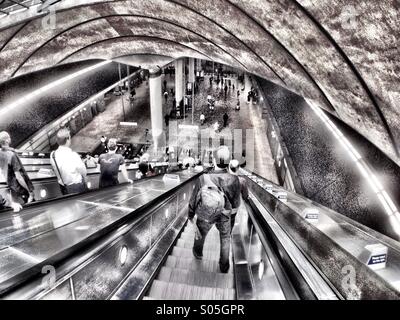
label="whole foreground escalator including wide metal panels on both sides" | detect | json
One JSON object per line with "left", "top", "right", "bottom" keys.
{"left": 0, "top": 171, "right": 400, "bottom": 300}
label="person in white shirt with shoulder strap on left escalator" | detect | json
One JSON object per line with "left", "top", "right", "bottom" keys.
{"left": 50, "top": 129, "right": 87, "bottom": 194}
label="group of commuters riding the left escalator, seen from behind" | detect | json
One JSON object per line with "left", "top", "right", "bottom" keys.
{"left": 0, "top": 128, "right": 159, "bottom": 212}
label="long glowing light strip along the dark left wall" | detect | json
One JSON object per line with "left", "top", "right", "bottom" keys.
{"left": 0, "top": 60, "right": 111, "bottom": 116}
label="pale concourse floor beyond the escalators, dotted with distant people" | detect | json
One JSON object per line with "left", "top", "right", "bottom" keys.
{"left": 71, "top": 70, "right": 278, "bottom": 183}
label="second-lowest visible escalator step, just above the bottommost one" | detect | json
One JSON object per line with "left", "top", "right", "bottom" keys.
{"left": 157, "top": 267, "right": 234, "bottom": 289}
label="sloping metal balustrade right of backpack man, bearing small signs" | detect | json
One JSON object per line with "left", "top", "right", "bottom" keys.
{"left": 242, "top": 170, "right": 400, "bottom": 299}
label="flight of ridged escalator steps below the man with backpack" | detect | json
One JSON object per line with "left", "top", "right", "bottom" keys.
{"left": 144, "top": 225, "right": 236, "bottom": 300}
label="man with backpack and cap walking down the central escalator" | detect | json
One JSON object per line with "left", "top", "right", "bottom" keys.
{"left": 189, "top": 146, "right": 240, "bottom": 273}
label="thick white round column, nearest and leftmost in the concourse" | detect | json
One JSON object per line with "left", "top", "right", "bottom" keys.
{"left": 149, "top": 67, "right": 165, "bottom": 150}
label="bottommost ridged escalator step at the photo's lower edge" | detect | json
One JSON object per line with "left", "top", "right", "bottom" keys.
{"left": 148, "top": 280, "right": 235, "bottom": 300}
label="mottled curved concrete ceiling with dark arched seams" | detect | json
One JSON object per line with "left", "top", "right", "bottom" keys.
{"left": 0, "top": 0, "right": 400, "bottom": 165}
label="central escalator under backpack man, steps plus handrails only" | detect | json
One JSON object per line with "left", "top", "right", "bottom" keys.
{"left": 109, "top": 172, "right": 337, "bottom": 300}
